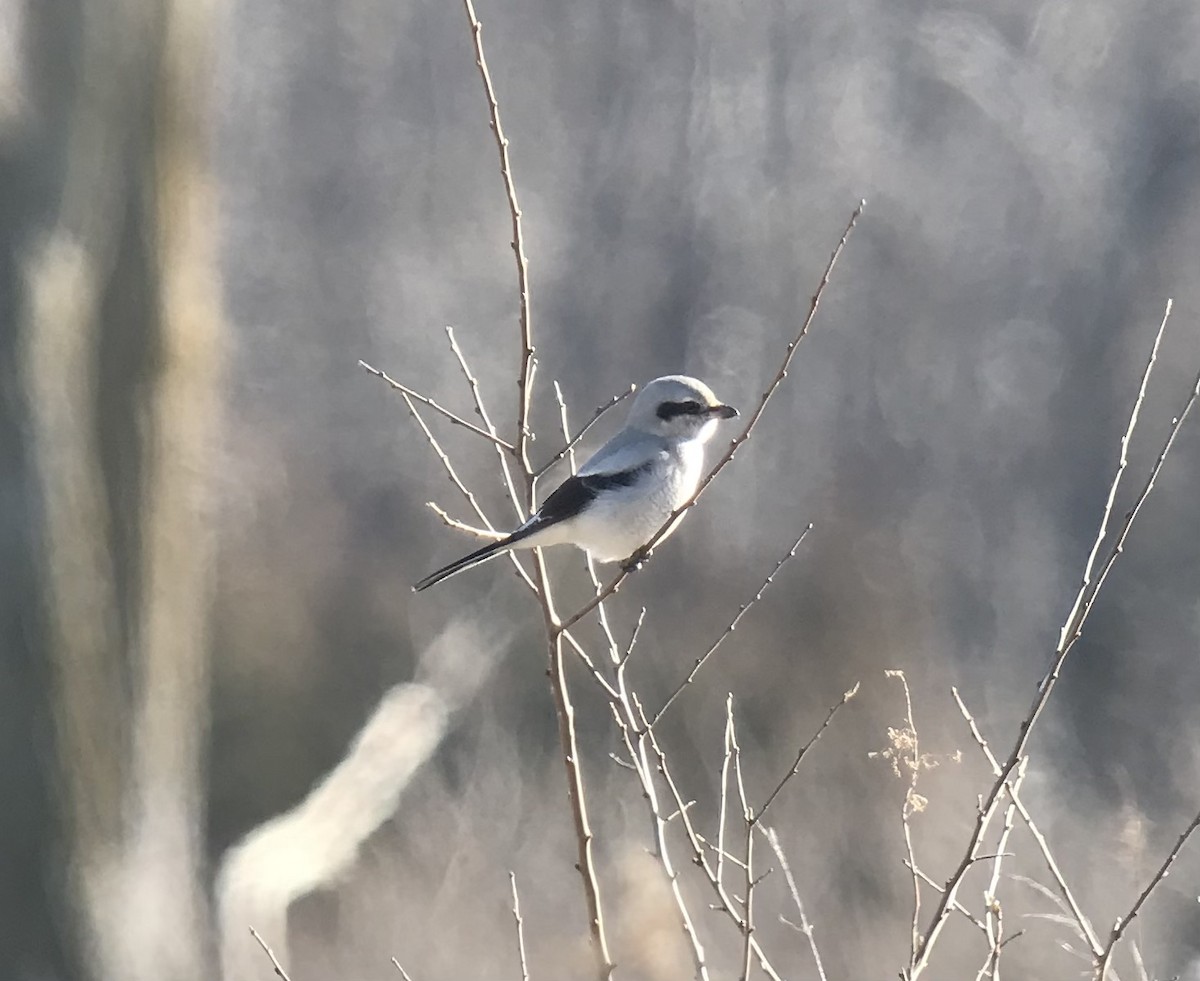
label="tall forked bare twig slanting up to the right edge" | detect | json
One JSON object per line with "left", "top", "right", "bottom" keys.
{"left": 908, "top": 302, "right": 1200, "bottom": 981}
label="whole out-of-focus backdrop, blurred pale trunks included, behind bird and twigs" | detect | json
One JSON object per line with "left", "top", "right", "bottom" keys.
{"left": 0, "top": 0, "right": 1200, "bottom": 981}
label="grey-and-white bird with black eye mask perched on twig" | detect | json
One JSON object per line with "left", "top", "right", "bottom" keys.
{"left": 413, "top": 374, "right": 738, "bottom": 592}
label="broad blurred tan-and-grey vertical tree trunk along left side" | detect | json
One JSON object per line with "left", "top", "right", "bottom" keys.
{"left": 5, "top": 0, "right": 222, "bottom": 981}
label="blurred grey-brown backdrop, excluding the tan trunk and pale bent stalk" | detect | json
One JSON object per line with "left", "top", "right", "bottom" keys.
{"left": 0, "top": 0, "right": 1200, "bottom": 979}
